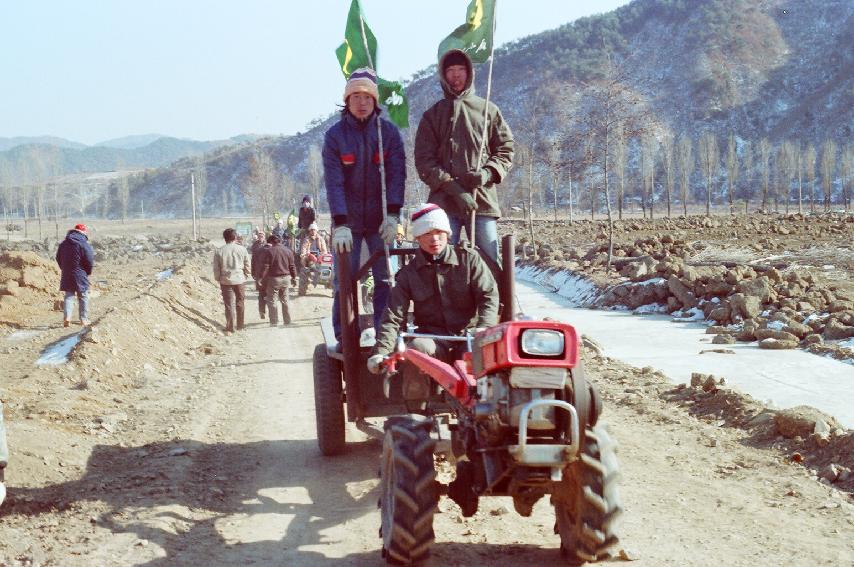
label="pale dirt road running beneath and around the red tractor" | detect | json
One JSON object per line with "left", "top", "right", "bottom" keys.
{"left": 0, "top": 271, "right": 854, "bottom": 566}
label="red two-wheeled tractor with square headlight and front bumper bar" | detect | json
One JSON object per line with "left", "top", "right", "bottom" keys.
{"left": 315, "top": 237, "right": 622, "bottom": 565}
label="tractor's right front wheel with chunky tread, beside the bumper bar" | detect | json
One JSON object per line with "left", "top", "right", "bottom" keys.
{"left": 552, "top": 424, "right": 623, "bottom": 565}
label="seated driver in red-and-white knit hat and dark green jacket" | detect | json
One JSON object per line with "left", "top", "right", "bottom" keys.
{"left": 368, "top": 204, "right": 498, "bottom": 386}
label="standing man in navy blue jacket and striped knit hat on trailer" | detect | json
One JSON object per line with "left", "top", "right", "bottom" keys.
{"left": 323, "top": 68, "right": 406, "bottom": 338}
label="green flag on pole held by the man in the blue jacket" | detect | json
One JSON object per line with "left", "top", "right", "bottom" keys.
{"left": 335, "top": 0, "right": 409, "bottom": 128}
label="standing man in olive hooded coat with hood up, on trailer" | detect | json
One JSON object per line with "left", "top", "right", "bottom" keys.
{"left": 415, "top": 49, "right": 513, "bottom": 263}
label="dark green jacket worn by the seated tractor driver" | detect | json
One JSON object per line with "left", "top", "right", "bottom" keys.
{"left": 374, "top": 246, "right": 498, "bottom": 354}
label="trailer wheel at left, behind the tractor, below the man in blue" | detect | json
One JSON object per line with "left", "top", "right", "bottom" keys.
{"left": 314, "top": 344, "right": 344, "bottom": 456}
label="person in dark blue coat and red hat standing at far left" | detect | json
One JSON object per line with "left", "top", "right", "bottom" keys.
{"left": 56, "top": 224, "right": 95, "bottom": 327}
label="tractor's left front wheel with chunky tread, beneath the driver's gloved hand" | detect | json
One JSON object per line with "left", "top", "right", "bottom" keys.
{"left": 379, "top": 417, "right": 439, "bottom": 565}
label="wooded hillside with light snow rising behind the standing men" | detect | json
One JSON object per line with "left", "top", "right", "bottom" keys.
{"left": 112, "top": 0, "right": 854, "bottom": 220}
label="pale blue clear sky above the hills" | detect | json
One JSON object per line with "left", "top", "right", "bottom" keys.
{"left": 0, "top": 0, "right": 627, "bottom": 144}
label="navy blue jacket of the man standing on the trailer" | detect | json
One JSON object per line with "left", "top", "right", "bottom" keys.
{"left": 323, "top": 112, "right": 406, "bottom": 233}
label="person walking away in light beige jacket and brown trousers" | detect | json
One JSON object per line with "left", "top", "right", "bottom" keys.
{"left": 214, "top": 228, "right": 252, "bottom": 334}
